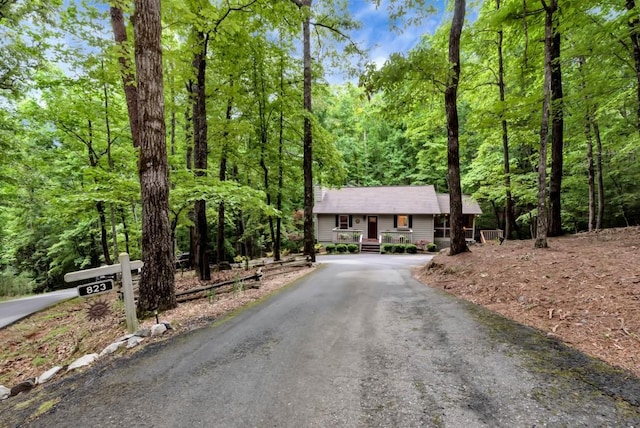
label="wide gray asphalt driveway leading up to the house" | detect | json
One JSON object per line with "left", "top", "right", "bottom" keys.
{"left": 8, "top": 255, "right": 640, "bottom": 428}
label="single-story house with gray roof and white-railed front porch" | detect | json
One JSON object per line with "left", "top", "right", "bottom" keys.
{"left": 313, "top": 186, "right": 482, "bottom": 250}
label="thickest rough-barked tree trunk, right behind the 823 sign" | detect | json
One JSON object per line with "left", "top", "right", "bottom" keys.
{"left": 134, "top": 0, "right": 177, "bottom": 313}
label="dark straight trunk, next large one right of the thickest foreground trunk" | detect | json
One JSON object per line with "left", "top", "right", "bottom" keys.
{"left": 191, "top": 31, "right": 211, "bottom": 281}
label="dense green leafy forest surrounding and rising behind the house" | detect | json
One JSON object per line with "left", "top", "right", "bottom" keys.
{"left": 0, "top": 0, "right": 640, "bottom": 294}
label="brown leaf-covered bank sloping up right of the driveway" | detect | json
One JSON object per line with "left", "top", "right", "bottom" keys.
{"left": 418, "top": 227, "right": 640, "bottom": 376}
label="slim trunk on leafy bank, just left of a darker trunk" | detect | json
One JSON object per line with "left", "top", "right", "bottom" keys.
{"left": 535, "top": 0, "right": 553, "bottom": 248}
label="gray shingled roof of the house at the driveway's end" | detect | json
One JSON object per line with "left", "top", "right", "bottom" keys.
{"left": 313, "top": 185, "right": 482, "bottom": 214}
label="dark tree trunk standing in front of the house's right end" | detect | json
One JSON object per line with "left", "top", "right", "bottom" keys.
{"left": 444, "top": 0, "right": 469, "bottom": 256}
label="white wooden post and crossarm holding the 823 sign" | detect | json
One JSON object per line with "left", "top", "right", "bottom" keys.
{"left": 64, "top": 253, "right": 143, "bottom": 333}
